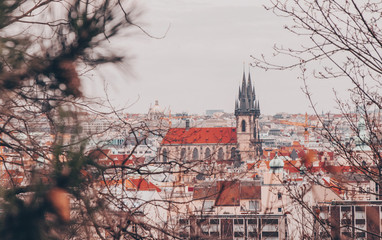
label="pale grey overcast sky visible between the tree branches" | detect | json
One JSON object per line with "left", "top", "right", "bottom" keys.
{"left": 85, "top": 0, "right": 354, "bottom": 114}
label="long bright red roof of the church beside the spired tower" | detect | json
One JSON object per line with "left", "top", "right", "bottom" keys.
{"left": 162, "top": 127, "right": 237, "bottom": 144}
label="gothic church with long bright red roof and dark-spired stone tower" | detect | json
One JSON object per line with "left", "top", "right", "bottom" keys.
{"left": 158, "top": 70, "right": 262, "bottom": 164}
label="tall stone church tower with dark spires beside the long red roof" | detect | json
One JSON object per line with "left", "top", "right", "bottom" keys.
{"left": 235, "top": 68, "right": 262, "bottom": 161}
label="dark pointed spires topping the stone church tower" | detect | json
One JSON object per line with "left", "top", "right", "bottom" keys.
{"left": 235, "top": 67, "right": 260, "bottom": 115}
